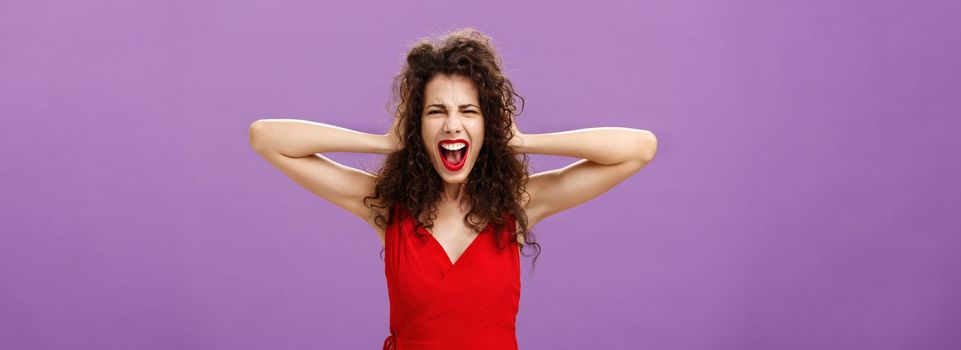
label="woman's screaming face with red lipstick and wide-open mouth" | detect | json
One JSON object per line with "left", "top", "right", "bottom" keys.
{"left": 421, "top": 74, "right": 484, "bottom": 184}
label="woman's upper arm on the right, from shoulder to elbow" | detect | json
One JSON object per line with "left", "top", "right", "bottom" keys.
{"left": 526, "top": 134, "right": 656, "bottom": 226}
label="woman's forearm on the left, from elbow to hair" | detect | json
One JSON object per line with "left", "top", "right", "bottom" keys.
{"left": 250, "top": 119, "right": 396, "bottom": 157}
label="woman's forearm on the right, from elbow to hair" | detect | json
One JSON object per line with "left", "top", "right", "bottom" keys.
{"left": 515, "top": 127, "right": 657, "bottom": 164}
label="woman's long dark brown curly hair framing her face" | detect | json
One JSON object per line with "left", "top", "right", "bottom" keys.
{"left": 364, "top": 28, "right": 541, "bottom": 268}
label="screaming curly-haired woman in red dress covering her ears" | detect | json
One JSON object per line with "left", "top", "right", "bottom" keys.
{"left": 250, "top": 28, "right": 657, "bottom": 349}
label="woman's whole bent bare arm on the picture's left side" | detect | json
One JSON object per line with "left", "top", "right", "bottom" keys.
{"left": 250, "top": 119, "right": 402, "bottom": 239}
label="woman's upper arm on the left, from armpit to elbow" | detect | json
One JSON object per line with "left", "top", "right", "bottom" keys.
{"left": 251, "top": 136, "right": 383, "bottom": 239}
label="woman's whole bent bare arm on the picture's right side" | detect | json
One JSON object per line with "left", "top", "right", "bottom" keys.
{"left": 509, "top": 123, "right": 657, "bottom": 226}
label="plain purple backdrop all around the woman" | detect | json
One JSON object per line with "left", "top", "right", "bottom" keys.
{"left": 0, "top": 0, "right": 961, "bottom": 349}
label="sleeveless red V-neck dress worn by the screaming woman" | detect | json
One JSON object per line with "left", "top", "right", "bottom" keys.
{"left": 384, "top": 205, "right": 521, "bottom": 350}
